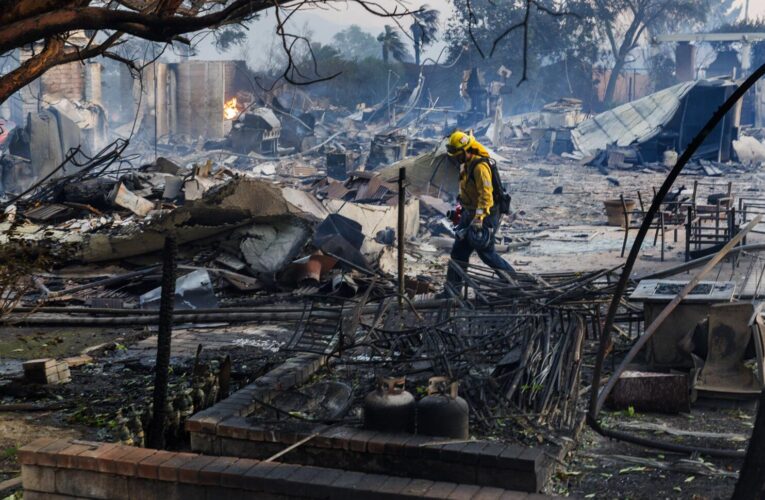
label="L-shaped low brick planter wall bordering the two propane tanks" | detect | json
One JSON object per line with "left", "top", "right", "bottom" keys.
{"left": 186, "top": 354, "right": 552, "bottom": 493}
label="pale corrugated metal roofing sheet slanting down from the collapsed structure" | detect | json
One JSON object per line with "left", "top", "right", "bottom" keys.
{"left": 571, "top": 82, "right": 698, "bottom": 154}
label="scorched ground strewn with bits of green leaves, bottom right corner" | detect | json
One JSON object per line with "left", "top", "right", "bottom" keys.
{"left": 551, "top": 403, "right": 755, "bottom": 499}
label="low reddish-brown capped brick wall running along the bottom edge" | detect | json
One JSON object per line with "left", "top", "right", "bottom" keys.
{"left": 19, "top": 439, "right": 547, "bottom": 500}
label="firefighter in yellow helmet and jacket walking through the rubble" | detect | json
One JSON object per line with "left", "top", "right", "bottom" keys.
{"left": 446, "top": 131, "right": 514, "bottom": 290}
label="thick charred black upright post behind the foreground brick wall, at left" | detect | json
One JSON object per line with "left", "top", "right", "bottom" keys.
{"left": 147, "top": 236, "right": 178, "bottom": 450}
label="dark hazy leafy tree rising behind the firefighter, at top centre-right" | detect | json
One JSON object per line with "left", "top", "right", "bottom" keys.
{"left": 444, "top": 0, "right": 601, "bottom": 113}
